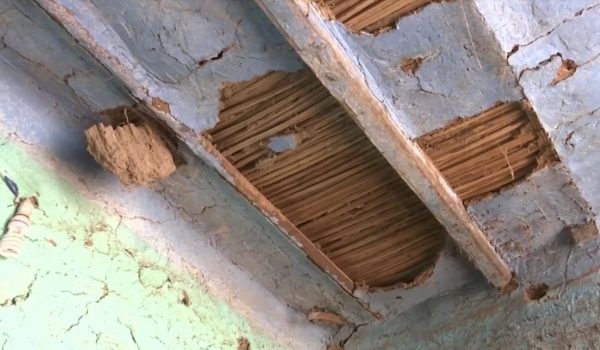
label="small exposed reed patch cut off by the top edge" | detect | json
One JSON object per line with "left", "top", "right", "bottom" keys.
{"left": 317, "top": 0, "right": 432, "bottom": 33}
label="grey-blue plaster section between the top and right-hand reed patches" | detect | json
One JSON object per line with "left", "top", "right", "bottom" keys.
{"left": 347, "top": 1, "right": 522, "bottom": 137}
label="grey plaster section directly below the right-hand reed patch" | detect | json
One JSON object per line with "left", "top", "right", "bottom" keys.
{"left": 468, "top": 165, "right": 600, "bottom": 286}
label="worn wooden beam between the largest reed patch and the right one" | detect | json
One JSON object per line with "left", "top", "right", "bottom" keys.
{"left": 255, "top": 0, "right": 512, "bottom": 287}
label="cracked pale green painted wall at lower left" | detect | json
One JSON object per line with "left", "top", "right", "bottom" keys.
{"left": 0, "top": 139, "right": 283, "bottom": 350}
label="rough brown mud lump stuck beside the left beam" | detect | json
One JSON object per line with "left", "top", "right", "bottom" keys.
{"left": 85, "top": 122, "right": 176, "bottom": 185}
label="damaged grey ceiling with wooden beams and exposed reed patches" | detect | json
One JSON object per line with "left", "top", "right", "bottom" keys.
{"left": 4, "top": 0, "right": 600, "bottom": 342}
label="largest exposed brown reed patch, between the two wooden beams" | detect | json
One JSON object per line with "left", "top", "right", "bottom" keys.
{"left": 207, "top": 71, "right": 445, "bottom": 287}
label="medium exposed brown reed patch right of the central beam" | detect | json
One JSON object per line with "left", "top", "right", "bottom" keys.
{"left": 418, "top": 102, "right": 555, "bottom": 200}
